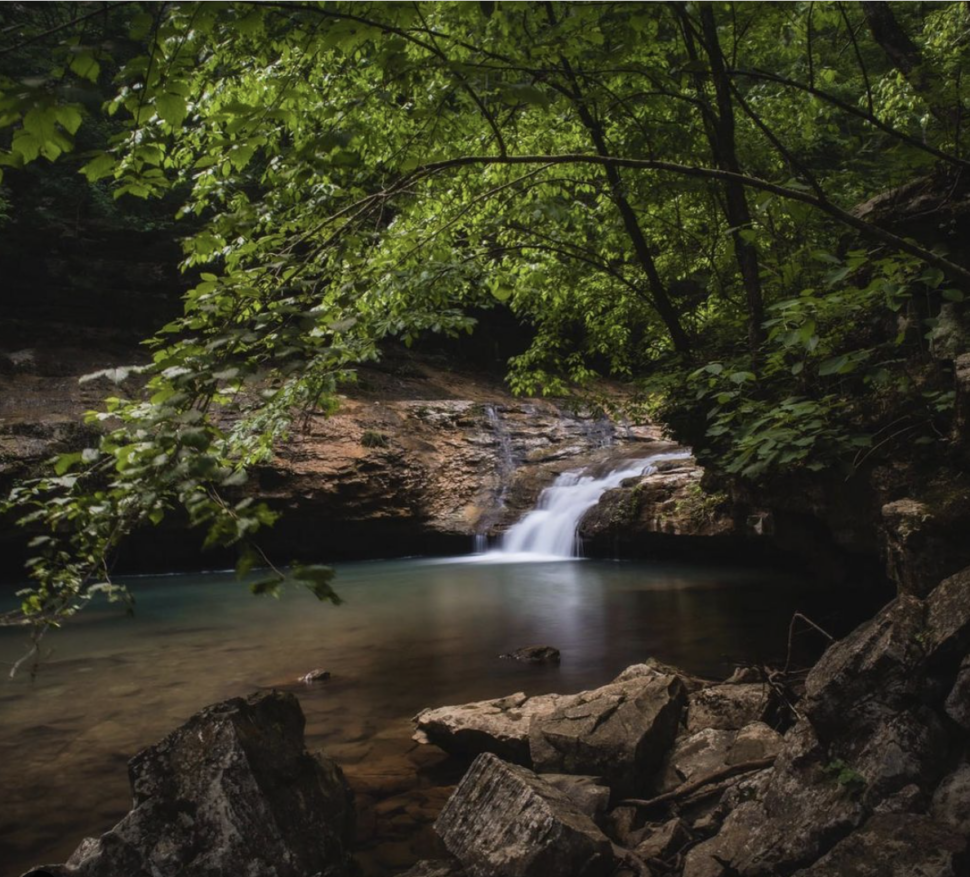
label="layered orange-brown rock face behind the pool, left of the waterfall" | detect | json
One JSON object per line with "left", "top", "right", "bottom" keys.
{"left": 0, "top": 346, "right": 670, "bottom": 573}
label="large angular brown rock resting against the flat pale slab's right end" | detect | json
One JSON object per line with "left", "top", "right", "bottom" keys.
{"left": 529, "top": 676, "right": 686, "bottom": 795}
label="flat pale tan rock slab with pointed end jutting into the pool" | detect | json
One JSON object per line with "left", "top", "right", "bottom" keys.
{"left": 414, "top": 692, "right": 563, "bottom": 766}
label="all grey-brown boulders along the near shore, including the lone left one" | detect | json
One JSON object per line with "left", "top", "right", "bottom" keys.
{"left": 28, "top": 569, "right": 970, "bottom": 877}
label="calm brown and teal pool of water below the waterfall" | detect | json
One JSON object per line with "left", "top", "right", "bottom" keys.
{"left": 0, "top": 559, "right": 874, "bottom": 875}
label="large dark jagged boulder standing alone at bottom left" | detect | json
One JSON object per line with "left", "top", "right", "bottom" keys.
{"left": 28, "top": 692, "right": 354, "bottom": 877}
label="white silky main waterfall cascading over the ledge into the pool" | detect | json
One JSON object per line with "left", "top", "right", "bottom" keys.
{"left": 501, "top": 451, "right": 690, "bottom": 557}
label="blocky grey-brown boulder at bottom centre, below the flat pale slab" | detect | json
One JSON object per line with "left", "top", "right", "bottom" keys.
{"left": 435, "top": 753, "right": 615, "bottom": 877}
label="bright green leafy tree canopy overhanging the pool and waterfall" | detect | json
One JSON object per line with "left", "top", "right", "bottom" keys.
{"left": 0, "top": 2, "right": 970, "bottom": 640}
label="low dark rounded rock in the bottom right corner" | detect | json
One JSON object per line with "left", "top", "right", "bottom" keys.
{"left": 795, "top": 813, "right": 970, "bottom": 877}
